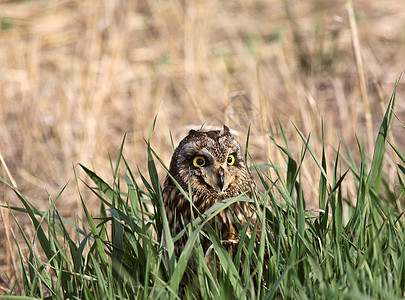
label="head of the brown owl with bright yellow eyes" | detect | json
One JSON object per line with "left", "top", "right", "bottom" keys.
{"left": 169, "top": 126, "right": 249, "bottom": 197}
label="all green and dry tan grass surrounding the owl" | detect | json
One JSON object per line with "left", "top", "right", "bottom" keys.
{"left": 0, "top": 0, "right": 405, "bottom": 298}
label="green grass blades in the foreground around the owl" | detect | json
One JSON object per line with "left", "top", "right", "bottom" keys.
{"left": 0, "top": 78, "right": 405, "bottom": 299}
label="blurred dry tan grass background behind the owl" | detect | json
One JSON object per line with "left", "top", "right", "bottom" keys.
{"left": 0, "top": 0, "right": 405, "bottom": 292}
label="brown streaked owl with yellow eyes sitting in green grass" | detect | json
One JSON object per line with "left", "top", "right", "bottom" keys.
{"left": 163, "top": 126, "right": 256, "bottom": 255}
